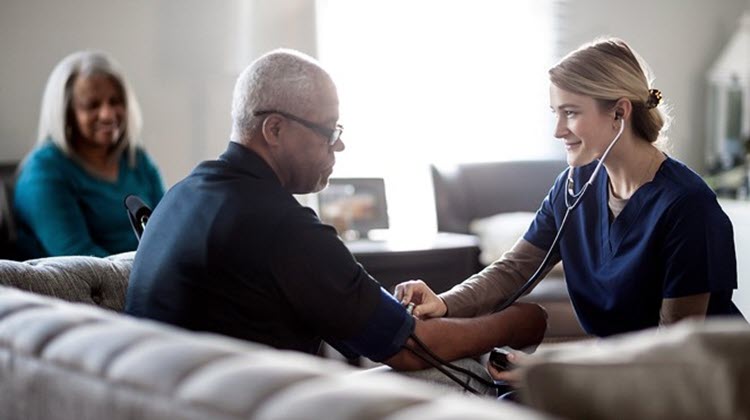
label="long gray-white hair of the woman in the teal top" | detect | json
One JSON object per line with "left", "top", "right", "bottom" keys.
{"left": 37, "top": 51, "right": 143, "bottom": 165}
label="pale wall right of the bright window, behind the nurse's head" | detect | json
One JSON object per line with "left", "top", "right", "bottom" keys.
{"left": 560, "top": 0, "right": 750, "bottom": 171}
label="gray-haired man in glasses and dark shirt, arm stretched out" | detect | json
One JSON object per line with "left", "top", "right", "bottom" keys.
{"left": 126, "top": 50, "right": 546, "bottom": 380}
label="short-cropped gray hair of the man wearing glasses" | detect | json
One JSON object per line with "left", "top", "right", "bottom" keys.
{"left": 231, "top": 49, "right": 331, "bottom": 141}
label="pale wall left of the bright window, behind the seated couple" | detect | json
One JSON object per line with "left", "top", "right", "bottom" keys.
{"left": 0, "top": 0, "right": 315, "bottom": 185}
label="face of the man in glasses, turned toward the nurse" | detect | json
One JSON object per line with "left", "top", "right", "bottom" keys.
{"left": 281, "top": 82, "right": 344, "bottom": 194}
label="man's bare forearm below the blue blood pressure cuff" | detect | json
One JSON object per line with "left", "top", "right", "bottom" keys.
{"left": 385, "top": 303, "right": 547, "bottom": 370}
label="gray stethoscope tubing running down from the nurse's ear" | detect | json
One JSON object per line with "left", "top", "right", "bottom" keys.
{"left": 493, "top": 115, "right": 625, "bottom": 312}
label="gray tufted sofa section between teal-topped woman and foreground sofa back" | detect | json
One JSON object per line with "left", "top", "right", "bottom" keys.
{"left": 0, "top": 252, "right": 135, "bottom": 312}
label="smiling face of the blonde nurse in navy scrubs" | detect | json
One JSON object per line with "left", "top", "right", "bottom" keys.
{"left": 549, "top": 84, "right": 619, "bottom": 166}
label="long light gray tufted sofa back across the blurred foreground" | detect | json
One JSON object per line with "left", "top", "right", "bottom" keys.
{"left": 0, "top": 287, "right": 546, "bottom": 420}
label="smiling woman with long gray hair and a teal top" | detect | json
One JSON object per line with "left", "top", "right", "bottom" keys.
{"left": 14, "top": 51, "right": 164, "bottom": 258}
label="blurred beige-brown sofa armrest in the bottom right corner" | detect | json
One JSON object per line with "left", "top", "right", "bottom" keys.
{"left": 521, "top": 318, "right": 750, "bottom": 419}
